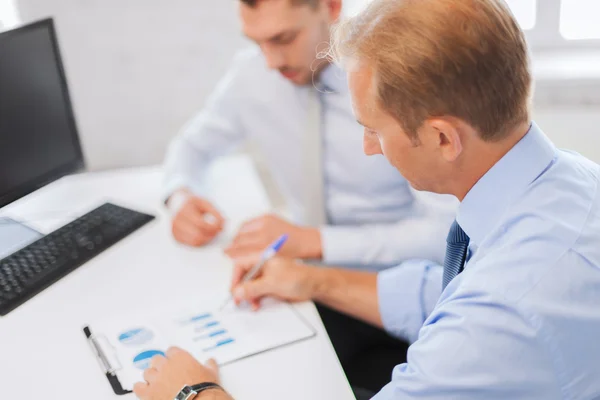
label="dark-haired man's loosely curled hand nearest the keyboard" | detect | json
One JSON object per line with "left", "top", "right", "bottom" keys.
{"left": 172, "top": 194, "right": 224, "bottom": 247}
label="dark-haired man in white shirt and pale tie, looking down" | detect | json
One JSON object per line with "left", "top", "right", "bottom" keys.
{"left": 159, "top": 0, "right": 456, "bottom": 390}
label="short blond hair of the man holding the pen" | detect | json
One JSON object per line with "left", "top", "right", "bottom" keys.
{"left": 330, "top": 0, "right": 532, "bottom": 141}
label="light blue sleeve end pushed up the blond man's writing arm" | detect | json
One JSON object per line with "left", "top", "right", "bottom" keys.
{"left": 377, "top": 260, "right": 442, "bottom": 343}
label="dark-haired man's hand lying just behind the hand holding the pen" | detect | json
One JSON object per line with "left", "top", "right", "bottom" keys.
{"left": 225, "top": 215, "right": 323, "bottom": 259}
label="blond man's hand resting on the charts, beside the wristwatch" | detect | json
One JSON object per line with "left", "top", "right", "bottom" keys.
{"left": 133, "top": 347, "right": 231, "bottom": 400}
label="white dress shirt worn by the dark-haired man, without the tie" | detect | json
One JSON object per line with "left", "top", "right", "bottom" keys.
{"left": 165, "top": 49, "right": 457, "bottom": 268}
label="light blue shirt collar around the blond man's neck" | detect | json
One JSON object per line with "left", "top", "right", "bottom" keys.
{"left": 456, "top": 122, "right": 556, "bottom": 246}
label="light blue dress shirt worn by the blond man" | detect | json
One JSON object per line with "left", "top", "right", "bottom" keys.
{"left": 375, "top": 124, "right": 600, "bottom": 400}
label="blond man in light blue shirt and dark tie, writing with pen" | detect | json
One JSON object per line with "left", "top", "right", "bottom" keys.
{"left": 136, "top": 0, "right": 600, "bottom": 400}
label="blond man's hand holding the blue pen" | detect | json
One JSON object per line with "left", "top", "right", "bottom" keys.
{"left": 231, "top": 257, "right": 319, "bottom": 310}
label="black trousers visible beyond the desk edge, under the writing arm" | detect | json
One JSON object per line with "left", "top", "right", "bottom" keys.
{"left": 317, "top": 305, "right": 408, "bottom": 399}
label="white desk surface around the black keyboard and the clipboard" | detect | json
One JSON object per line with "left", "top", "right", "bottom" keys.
{"left": 0, "top": 157, "right": 354, "bottom": 400}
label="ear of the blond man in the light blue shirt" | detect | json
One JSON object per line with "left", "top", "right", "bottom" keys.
{"left": 421, "top": 118, "right": 463, "bottom": 162}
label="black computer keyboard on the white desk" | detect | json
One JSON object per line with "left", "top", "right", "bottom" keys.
{"left": 0, "top": 203, "right": 154, "bottom": 315}
